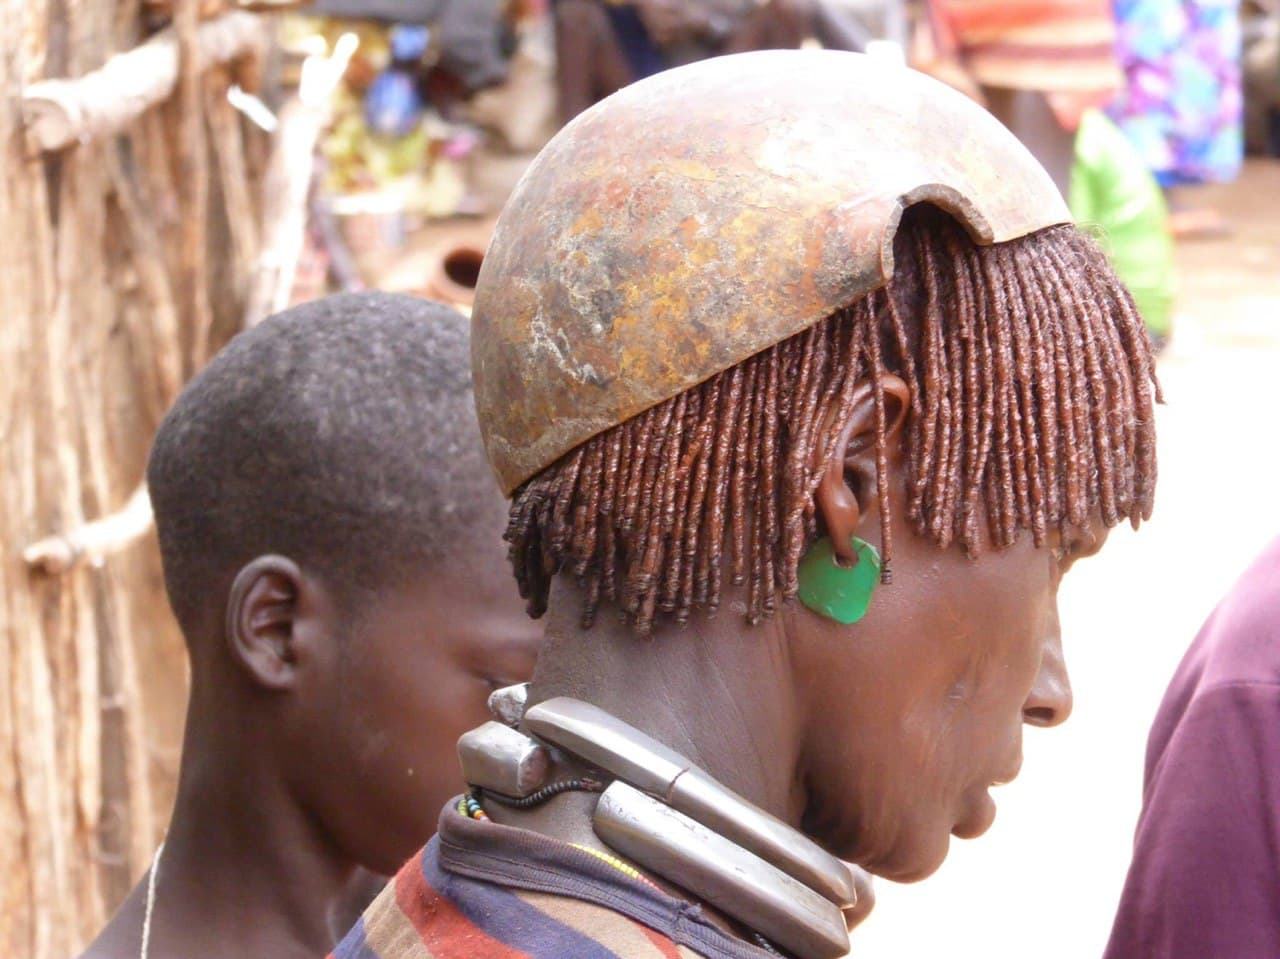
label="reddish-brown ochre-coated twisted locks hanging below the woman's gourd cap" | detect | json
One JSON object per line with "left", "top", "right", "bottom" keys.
{"left": 507, "top": 207, "right": 1160, "bottom": 634}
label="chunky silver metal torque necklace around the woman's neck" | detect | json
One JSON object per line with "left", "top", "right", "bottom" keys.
{"left": 458, "top": 686, "right": 858, "bottom": 959}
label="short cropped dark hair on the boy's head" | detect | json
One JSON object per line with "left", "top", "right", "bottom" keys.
{"left": 147, "top": 293, "right": 503, "bottom": 630}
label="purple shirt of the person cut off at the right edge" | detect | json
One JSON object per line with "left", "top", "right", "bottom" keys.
{"left": 1106, "top": 540, "right": 1280, "bottom": 959}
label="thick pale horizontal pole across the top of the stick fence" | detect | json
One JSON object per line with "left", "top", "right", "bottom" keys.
{"left": 22, "top": 12, "right": 266, "bottom": 150}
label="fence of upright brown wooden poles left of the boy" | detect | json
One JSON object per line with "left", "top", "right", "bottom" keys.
{"left": 0, "top": 0, "right": 265, "bottom": 959}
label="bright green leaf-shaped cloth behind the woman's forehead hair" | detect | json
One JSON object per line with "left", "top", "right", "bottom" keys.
{"left": 1070, "top": 110, "right": 1174, "bottom": 335}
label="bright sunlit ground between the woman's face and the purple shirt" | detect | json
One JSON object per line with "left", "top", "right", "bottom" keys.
{"left": 852, "top": 161, "right": 1280, "bottom": 959}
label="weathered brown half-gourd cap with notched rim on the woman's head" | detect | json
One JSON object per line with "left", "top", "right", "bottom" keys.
{"left": 471, "top": 51, "right": 1070, "bottom": 496}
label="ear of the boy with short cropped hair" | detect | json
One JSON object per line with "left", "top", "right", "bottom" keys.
{"left": 227, "top": 556, "right": 302, "bottom": 690}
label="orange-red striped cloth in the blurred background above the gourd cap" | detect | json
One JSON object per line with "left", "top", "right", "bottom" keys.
{"left": 928, "top": 0, "right": 1123, "bottom": 93}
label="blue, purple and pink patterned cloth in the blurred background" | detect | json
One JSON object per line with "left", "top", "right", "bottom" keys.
{"left": 1108, "top": 0, "right": 1244, "bottom": 187}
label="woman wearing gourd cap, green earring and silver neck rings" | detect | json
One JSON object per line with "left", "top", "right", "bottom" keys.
{"left": 338, "top": 51, "right": 1158, "bottom": 959}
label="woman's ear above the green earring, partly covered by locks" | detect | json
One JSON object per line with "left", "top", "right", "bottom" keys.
{"left": 814, "top": 373, "right": 911, "bottom": 563}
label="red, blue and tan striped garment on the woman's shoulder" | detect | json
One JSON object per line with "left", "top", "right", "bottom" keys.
{"left": 330, "top": 804, "right": 771, "bottom": 959}
